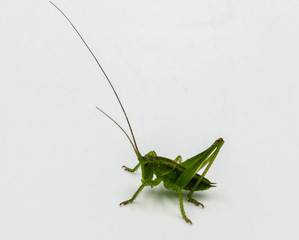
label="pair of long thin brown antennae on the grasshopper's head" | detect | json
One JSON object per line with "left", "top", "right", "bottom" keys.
{"left": 50, "top": 1, "right": 140, "bottom": 155}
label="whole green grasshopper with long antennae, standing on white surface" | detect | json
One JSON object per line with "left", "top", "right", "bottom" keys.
{"left": 50, "top": 2, "right": 224, "bottom": 224}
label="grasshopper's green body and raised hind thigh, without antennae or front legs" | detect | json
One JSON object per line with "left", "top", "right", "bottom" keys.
{"left": 138, "top": 138, "right": 224, "bottom": 191}
